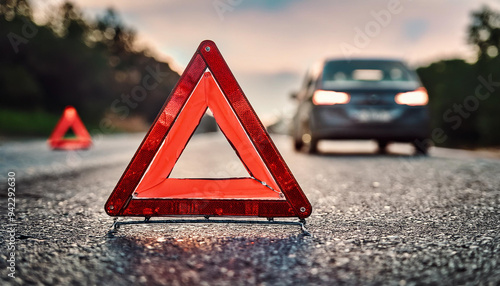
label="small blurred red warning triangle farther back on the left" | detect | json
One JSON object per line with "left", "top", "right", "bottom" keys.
{"left": 49, "top": 106, "right": 92, "bottom": 150}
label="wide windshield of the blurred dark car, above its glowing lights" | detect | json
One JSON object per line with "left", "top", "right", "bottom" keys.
{"left": 322, "top": 60, "right": 419, "bottom": 89}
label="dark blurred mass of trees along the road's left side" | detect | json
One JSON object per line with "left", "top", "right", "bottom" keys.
{"left": 0, "top": 0, "right": 179, "bottom": 133}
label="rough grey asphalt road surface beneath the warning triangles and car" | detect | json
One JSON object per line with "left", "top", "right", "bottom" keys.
{"left": 0, "top": 134, "right": 500, "bottom": 285}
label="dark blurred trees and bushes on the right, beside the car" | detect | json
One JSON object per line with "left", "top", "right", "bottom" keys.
{"left": 417, "top": 7, "right": 500, "bottom": 147}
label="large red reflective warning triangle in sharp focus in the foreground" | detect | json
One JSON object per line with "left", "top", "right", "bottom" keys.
{"left": 105, "top": 41, "right": 312, "bottom": 218}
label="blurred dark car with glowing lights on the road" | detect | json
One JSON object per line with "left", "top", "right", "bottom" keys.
{"left": 291, "top": 59, "right": 430, "bottom": 154}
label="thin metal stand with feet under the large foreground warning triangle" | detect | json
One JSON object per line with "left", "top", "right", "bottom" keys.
{"left": 108, "top": 217, "right": 311, "bottom": 236}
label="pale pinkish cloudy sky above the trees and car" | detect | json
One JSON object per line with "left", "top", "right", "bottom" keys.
{"left": 34, "top": 0, "right": 500, "bottom": 116}
